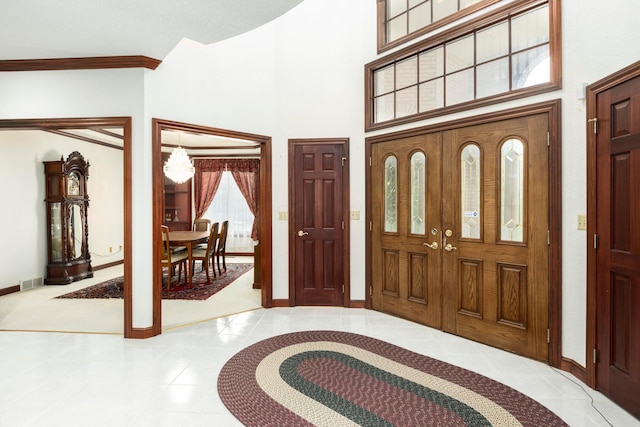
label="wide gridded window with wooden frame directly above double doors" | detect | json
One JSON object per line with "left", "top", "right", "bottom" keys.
{"left": 365, "top": 0, "right": 561, "bottom": 130}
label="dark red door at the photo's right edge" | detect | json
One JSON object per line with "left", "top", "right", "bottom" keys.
{"left": 596, "top": 77, "right": 640, "bottom": 418}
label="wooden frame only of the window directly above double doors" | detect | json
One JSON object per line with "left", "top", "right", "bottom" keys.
{"left": 365, "top": 0, "right": 562, "bottom": 132}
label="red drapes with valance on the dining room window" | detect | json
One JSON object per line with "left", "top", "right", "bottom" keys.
{"left": 193, "top": 159, "right": 260, "bottom": 240}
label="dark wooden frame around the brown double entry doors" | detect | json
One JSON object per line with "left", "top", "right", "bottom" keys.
{"left": 365, "top": 99, "right": 564, "bottom": 368}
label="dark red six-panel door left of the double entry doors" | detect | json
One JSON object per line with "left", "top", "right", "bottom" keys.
{"left": 289, "top": 141, "right": 346, "bottom": 306}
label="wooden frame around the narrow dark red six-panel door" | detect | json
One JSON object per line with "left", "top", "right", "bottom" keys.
{"left": 288, "top": 138, "right": 351, "bottom": 307}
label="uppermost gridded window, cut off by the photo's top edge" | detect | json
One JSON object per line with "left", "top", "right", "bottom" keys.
{"left": 378, "top": 0, "right": 500, "bottom": 52}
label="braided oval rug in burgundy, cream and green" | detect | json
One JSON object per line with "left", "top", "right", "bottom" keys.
{"left": 218, "top": 331, "right": 567, "bottom": 427}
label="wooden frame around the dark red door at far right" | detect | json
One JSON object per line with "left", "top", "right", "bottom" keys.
{"left": 585, "top": 61, "right": 640, "bottom": 388}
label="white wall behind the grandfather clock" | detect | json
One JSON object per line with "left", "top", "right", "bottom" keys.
{"left": 0, "top": 131, "right": 124, "bottom": 287}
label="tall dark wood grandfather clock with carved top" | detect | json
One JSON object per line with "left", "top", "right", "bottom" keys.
{"left": 43, "top": 151, "right": 93, "bottom": 285}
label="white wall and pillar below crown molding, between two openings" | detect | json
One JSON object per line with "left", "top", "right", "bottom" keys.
{"left": 0, "top": 69, "right": 152, "bottom": 328}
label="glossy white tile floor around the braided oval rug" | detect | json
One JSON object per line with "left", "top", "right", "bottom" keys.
{"left": 0, "top": 307, "right": 640, "bottom": 427}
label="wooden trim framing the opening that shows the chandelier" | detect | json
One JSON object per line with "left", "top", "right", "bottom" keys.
{"left": 151, "top": 118, "right": 273, "bottom": 335}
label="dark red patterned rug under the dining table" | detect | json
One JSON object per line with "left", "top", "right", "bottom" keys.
{"left": 57, "top": 263, "right": 253, "bottom": 301}
